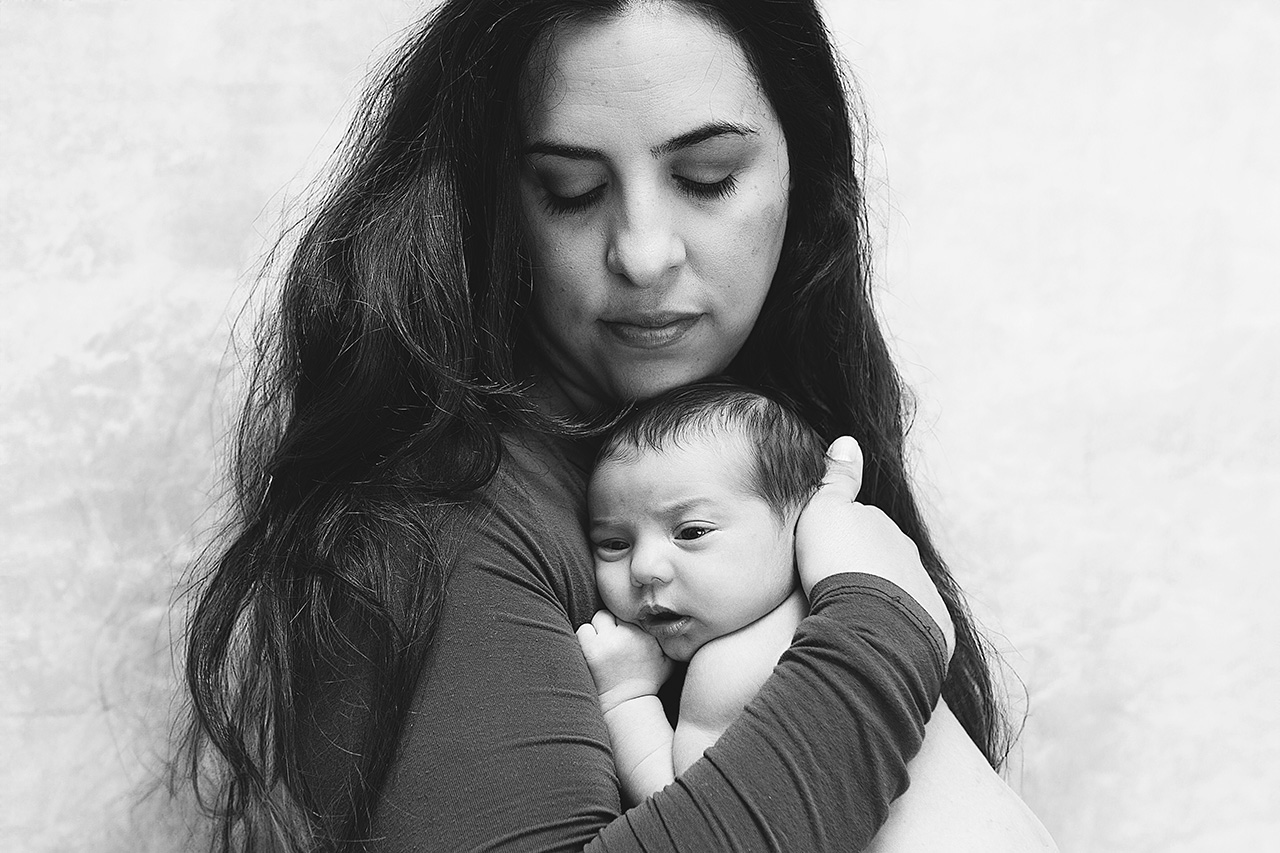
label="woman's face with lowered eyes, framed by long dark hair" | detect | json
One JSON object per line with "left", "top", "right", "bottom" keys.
{"left": 520, "top": 3, "right": 790, "bottom": 411}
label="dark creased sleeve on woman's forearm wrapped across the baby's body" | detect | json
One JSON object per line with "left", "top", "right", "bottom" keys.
{"left": 599, "top": 574, "right": 945, "bottom": 853}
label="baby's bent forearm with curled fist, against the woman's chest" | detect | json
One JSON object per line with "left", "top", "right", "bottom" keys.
{"left": 577, "top": 610, "right": 676, "bottom": 807}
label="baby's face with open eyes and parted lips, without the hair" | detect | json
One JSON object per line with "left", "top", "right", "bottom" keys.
{"left": 588, "top": 435, "right": 795, "bottom": 661}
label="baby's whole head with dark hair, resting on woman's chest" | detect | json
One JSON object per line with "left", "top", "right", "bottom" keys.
{"left": 588, "top": 382, "right": 826, "bottom": 661}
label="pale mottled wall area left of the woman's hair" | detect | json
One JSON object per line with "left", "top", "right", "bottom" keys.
{"left": 0, "top": 0, "right": 413, "bottom": 852}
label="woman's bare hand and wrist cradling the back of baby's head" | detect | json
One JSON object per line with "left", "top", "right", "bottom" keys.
{"left": 796, "top": 435, "right": 955, "bottom": 654}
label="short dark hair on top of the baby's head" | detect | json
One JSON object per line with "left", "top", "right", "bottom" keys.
{"left": 595, "top": 379, "right": 827, "bottom": 517}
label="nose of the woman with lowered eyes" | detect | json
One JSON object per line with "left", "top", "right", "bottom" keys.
{"left": 604, "top": 193, "right": 685, "bottom": 287}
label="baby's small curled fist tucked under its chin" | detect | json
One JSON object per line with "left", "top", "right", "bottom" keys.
{"left": 577, "top": 610, "right": 671, "bottom": 712}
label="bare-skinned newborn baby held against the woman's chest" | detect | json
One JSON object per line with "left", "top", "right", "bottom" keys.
{"left": 577, "top": 383, "right": 1056, "bottom": 850}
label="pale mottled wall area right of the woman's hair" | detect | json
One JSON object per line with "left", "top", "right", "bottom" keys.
{"left": 829, "top": 1, "right": 1280, "bottom": 852}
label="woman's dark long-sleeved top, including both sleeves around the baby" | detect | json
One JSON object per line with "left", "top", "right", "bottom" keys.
{"left": 296, "top": 432, "right": 942, "bottom": 853}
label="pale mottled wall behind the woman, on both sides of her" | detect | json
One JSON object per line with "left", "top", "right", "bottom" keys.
{"left": 0, "top": 0, "right": 1280, "bottom": 853}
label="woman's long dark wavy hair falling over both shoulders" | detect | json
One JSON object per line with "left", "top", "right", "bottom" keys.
{"left": 183, "top": 0, "right": 1005, "bottom": 850}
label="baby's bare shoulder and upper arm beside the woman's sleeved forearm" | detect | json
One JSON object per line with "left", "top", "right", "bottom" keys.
{"left": 672, "top": 589, "right": 809, "bottom": 774}
